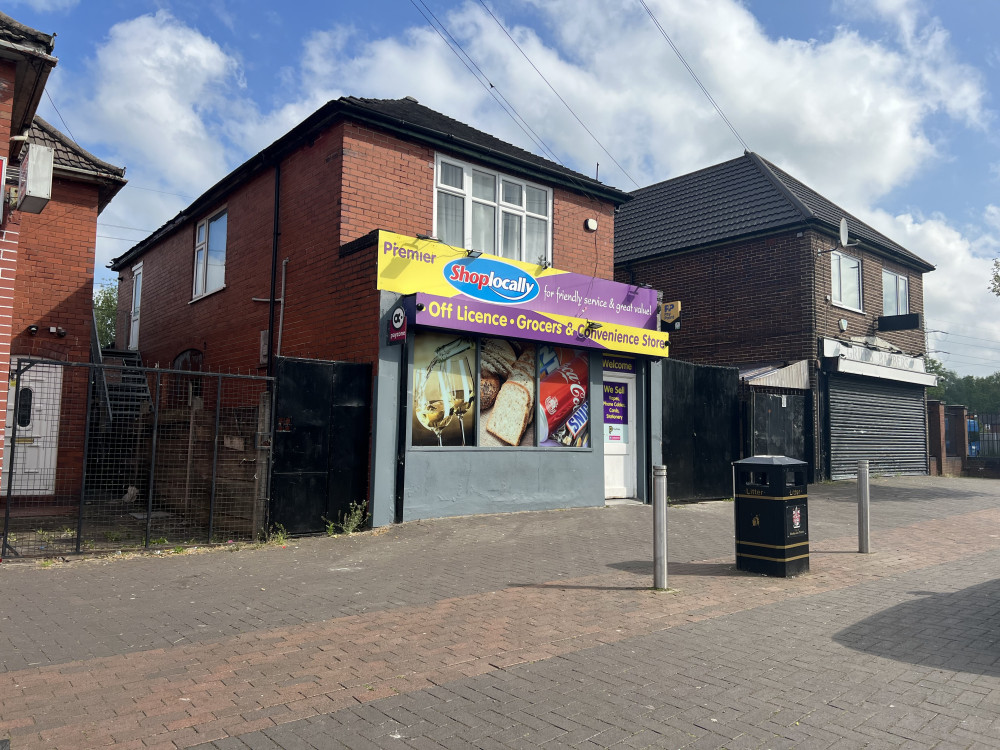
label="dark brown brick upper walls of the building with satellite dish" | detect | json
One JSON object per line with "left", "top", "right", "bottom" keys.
{"left": 616, "top": 231, "right": 924, "bottom": 366}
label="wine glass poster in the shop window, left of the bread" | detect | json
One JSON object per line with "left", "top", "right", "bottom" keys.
{"left": 412, "top": 331, "right": 476, "bottom": 447}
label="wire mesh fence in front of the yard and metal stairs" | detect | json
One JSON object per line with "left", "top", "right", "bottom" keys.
{"left": 0, "top": 360, "right": 272, "bottom": 556}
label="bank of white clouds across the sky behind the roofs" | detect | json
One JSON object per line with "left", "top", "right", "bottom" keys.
{"left": 53, "top": 0, "right": 1000, "bottom": 374}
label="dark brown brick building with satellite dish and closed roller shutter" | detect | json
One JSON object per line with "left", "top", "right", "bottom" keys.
{"left": 615, "top": 152, "right": 936, "bottom": 479}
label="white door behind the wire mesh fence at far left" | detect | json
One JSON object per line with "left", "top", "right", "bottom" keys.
{"left": 0, "top": 364, "right": 62, "bottom": 495}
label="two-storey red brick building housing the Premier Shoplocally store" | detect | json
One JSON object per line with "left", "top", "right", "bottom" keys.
{"left": 111, "top": 97, "right": 666, "bottom": 530}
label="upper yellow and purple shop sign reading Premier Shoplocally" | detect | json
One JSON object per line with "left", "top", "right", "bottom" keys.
{"left": 377, "top": 232, "right": 666, "bottom": 332}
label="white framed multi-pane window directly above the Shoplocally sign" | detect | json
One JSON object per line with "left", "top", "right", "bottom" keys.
{"left": 434, "top": 154, "right": 552, "bottom": 264}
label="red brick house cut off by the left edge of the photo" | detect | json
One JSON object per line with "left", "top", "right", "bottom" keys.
{"left": 0, "top": 13, "right": 125, "bottom": 505}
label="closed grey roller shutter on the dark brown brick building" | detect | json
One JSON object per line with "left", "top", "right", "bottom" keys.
{"left": 827, "top": 374, "right": 927, "bottom": 479}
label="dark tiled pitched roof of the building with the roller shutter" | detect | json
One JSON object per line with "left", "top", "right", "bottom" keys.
{"left": 615, "top": 151, "right": 934, "bottom": 271}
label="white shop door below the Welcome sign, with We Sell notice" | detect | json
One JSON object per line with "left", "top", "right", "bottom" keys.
{"left": 604, "top": 371, "right": 636, "bottom": 498}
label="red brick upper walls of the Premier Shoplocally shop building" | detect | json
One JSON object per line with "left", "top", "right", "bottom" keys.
{"left": 118, "top": 122, "right": 614, "bottom": 372}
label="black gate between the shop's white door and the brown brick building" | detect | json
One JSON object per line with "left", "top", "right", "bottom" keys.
{"left": 663, "top": 359, "right": 740, "bottom": 500}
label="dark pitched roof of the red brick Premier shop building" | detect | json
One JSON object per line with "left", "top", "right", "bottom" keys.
{"left": 109, "top": 96, "right": 631, "bottom": 271}
